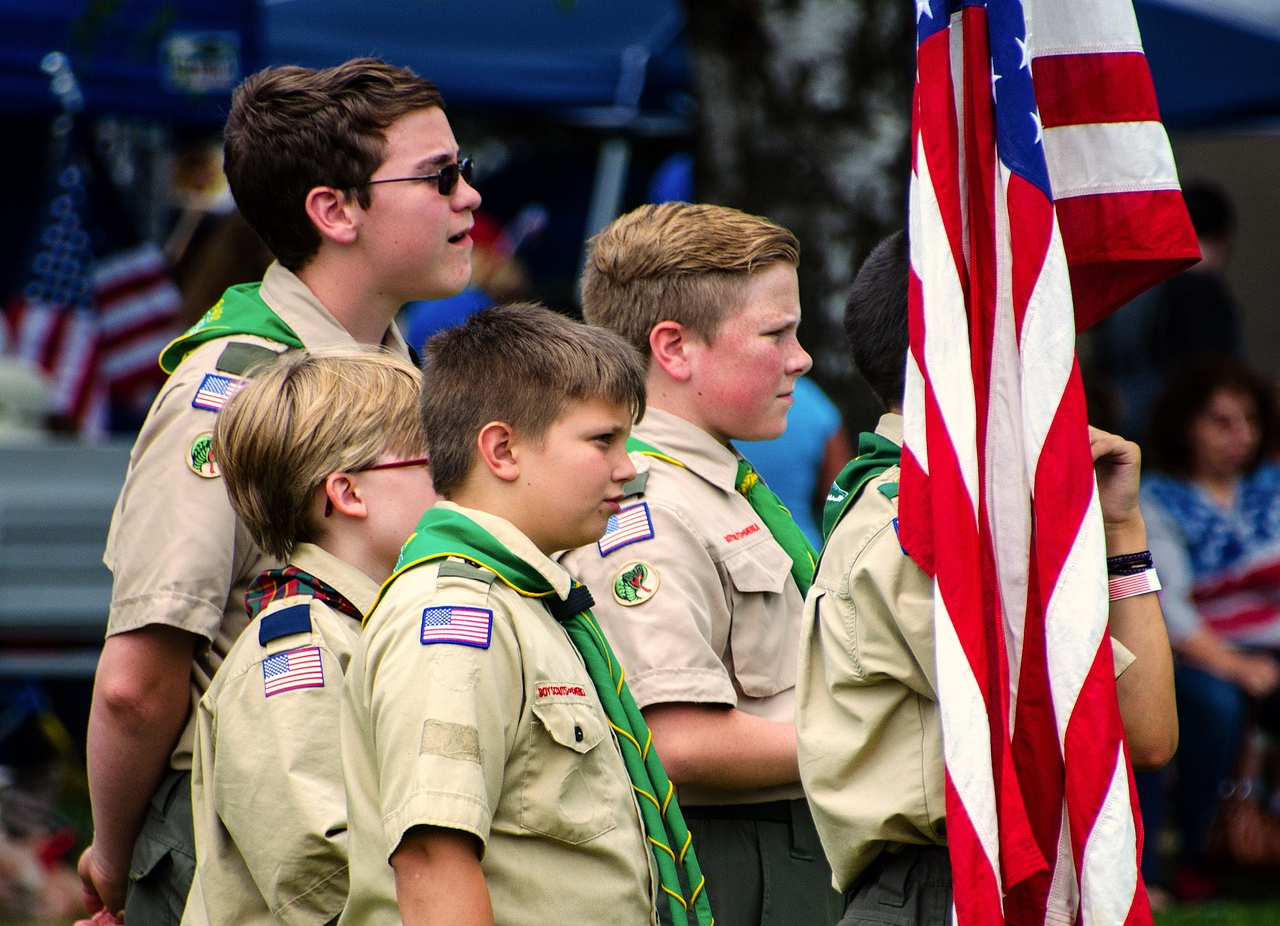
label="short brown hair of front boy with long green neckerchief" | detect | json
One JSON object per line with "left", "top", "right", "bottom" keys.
{"left": 421, "top": 302, "right": 645, "bottom": 498}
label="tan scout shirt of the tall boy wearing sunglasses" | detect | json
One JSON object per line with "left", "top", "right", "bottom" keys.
{"left": 102, "top": 264, "right": 408, "bottom": 768}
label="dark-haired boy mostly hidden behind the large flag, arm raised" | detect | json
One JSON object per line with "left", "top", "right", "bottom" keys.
{"left": 796, "top": 232, "right": 1178, "bottom": 926}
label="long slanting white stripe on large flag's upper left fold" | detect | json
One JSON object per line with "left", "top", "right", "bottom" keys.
{"left": 910, "top": 145, "right": 978, "bottom": 514}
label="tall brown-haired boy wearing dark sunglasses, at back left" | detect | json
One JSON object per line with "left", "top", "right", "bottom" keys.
{"left": 81, "top": 59, "right": 480, "bottom": 926}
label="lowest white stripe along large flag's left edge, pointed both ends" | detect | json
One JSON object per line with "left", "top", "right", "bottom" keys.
{"left": 933, "top": 583, "right": 1004, "bottom": 894}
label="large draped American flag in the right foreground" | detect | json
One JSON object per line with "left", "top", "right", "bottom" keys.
{"left": 900, "top": 0, "right": 1198, "bottom": 926}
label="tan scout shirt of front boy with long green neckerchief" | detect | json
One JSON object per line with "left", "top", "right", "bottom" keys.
{"left": 339, "top": 502, "right": 655, "bottom": 926}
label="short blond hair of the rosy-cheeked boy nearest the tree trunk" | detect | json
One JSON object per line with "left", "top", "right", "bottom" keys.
{"left": 582, "top": 202, "right": 800, "bottom": 359}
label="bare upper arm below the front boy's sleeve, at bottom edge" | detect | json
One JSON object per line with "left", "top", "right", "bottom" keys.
{"left": 390, "top": 826, "right": 494, "bottom": 926}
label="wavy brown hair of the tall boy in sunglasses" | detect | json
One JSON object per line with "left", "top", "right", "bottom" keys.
{"left": 224, "top": 58, "right": 444, "bottom": 270}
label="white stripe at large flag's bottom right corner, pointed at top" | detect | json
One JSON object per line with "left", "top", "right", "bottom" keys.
{"left": 1080, "top": 747, "right": 1138, "bottom": 926}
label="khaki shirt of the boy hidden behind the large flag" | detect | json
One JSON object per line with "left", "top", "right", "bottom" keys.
{"left": 796, "top": 414, "right": 1133, "bottom": 891}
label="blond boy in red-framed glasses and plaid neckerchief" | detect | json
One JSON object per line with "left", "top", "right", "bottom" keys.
{"left": 183, "top": 350, "right": 435, "bottom": 926}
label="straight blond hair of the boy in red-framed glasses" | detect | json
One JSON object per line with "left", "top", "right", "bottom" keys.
{"left": 212, "top": 348, "right": 426, "bottom": 560}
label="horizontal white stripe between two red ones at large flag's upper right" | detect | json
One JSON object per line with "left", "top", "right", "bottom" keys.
{"left": 1044, "top": 122, "right": 1179, "bottom": 200}
